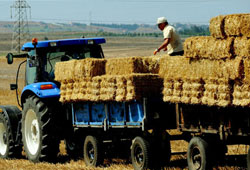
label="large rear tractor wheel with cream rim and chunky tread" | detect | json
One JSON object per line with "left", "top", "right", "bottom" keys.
{"left": 22, "top": 96, "right": 60, "bottom": 162}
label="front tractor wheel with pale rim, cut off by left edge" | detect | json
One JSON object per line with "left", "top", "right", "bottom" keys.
{"left": 0, "top": 112, "right": 22, "bottom": 159}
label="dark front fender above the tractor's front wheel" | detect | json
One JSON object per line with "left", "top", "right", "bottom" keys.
{"left": 0, "top": 106, "right": 22, "bottom": 141}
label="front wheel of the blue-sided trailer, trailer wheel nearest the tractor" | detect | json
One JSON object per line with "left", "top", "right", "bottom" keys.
{"left": 83, "top": 136, "right": 103, "bottom": 166}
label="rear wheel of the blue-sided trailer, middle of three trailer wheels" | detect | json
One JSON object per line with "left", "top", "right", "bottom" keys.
{"left": 131, "top": 137, "right": 151, "bottom": 170}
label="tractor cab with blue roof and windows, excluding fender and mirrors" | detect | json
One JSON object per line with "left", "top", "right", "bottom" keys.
{"left": 22, "top": 38, "right": 105, "bottom": 85}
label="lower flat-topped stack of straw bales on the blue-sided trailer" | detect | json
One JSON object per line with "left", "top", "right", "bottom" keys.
{"left": 55, "top": 57, "right": 163, "bottom": 103}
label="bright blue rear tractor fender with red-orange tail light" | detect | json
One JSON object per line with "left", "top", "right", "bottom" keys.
{"left": 21, "top": 82, "right": 60, "bottom": 104}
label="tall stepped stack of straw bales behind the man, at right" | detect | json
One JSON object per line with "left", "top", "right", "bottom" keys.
{"left": 159, "top": 14, "right": 250, "bottom": 107}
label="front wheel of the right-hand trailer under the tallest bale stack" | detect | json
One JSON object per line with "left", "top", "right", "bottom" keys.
{"left": 187, "top": 137, "right": 211, "bottom": 170}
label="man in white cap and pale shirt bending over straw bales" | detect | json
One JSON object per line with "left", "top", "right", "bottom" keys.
{"left": 154, "top": 17, "right": 184, "bottom": 56}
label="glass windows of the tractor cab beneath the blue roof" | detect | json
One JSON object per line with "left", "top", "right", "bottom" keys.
{"left": 26, "top": 45, "right": 104, "bottom": 84}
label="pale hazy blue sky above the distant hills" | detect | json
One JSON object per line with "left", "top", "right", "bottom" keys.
{"left": 0, "top": 0, "right": 250, "bottom": 24}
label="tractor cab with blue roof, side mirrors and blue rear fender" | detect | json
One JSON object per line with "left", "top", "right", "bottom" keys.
{"left": 6, "top": 38, "right": 106, "bottom": 106}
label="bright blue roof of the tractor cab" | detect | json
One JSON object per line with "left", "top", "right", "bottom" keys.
{"left": 22, "top": 38, "right": 106, "bottom": 51}
